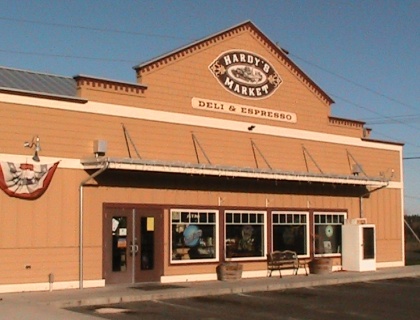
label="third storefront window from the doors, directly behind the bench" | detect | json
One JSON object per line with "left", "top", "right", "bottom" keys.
{"left": 273, "top": 212, "right": 309, "bottom": 256}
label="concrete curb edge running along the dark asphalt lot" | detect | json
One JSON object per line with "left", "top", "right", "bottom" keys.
{"left": 45, "top": 266, "right": 420, "bottom": 308}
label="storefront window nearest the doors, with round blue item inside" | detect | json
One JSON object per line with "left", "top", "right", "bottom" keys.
{"left": 171, "top": 209, "right": 218, "bottom": 263}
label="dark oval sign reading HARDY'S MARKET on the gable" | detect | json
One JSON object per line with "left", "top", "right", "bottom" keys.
{"left": 209, "top": 51, "right": 282, "bottom": 99}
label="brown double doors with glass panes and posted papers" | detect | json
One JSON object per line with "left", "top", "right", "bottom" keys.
{"left": 103, "top": 206, "right": 163, "bottom": 284}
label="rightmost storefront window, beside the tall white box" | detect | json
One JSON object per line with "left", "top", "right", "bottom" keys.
{"left": 314, "top": 212, "right": 346, "bottom": 255}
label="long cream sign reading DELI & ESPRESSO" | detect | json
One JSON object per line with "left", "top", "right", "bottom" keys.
{"left": 191, "top": 98, "right": 297, "bottom": 123}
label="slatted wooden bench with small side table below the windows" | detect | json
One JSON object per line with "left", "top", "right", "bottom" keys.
{"left": 267, "top": 250, "right": 310, "bottom": 278}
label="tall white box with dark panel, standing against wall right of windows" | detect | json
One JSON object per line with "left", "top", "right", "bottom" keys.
{"left": 342, "top": 222, "right": 376, "bottom": 271}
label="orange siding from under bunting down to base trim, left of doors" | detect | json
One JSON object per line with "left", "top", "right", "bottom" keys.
{"left": 0, "top": 169, "right": 102, "bottom": 284}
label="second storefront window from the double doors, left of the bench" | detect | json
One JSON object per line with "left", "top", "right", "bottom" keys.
{"left": 225, "top": 211, "right": 266, "bottom": 259}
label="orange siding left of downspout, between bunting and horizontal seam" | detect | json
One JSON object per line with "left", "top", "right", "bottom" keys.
{"left": 0, "top": 170, "right": 83, "bottom": 248}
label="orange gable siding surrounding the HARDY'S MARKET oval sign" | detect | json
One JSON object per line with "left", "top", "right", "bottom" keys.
{"left": 135, "top": 33, "right": 330, "bottom": 130}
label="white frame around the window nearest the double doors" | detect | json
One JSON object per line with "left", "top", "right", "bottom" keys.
{"left": 169, "top": 208, "right": 220, "bottom": 264}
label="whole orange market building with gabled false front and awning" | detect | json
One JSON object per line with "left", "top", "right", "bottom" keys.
{"left": 0, "top": 21, "right": 404, "bottom": 292}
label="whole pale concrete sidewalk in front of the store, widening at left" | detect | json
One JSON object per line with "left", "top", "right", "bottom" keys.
{"left": 0, "top": 265, "right": 420, "bottom": 320}
